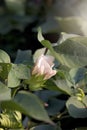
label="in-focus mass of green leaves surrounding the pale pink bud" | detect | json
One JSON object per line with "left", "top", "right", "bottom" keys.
{"left": 0, "top": 29, "right": 87, "bottom": 130}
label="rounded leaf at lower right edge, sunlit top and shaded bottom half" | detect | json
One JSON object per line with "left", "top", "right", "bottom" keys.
{"left": 66, "top": 96, "right": 87, "bottom": 118}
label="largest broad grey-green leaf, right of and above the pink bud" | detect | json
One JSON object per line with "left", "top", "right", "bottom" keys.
{"left": 54, "top": 36, "right": 87, "bottom": 68}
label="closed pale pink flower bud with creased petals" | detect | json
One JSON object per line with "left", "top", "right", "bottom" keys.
{"left": 32, "top": 55, "right": 56, "bottom": 80}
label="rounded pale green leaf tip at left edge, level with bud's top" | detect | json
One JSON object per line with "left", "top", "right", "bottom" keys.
{"left": 0, "top": 49, "right": 10, "bottom": 63}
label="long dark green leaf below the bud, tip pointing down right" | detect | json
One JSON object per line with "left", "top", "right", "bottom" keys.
{"left": 1, "top": 91, "right": 52, "bottom": 124}
